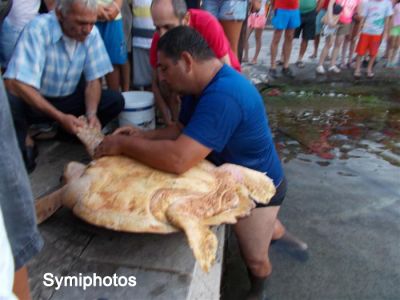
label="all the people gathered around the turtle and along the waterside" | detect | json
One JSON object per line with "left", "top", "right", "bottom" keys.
{"left": 0, "top": 0, "right": 400, "bottom": 299}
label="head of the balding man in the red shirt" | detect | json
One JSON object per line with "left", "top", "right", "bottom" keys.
{"left": 151, "top": 0, "right": 189, "bottom": 36}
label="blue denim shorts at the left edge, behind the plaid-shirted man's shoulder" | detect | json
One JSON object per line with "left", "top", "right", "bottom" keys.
{"left": 0, "top": 18, "right": 22, "bottom": 68}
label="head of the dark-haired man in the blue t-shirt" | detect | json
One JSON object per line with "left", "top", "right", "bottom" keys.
{"left": 157, "top": 26, "right": 219, "bottom": 95}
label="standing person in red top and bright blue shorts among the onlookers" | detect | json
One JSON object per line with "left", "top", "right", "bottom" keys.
{"left": 269, "top": 0, "right": 300, "bottom": 78}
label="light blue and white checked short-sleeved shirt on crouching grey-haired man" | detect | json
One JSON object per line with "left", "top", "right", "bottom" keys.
{"left": 4, "top": 12, "right": 113, "bottom": 97}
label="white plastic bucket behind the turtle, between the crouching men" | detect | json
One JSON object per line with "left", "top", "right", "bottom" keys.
{"left": 119, "top": 91, "right": 156, "bottom": 130}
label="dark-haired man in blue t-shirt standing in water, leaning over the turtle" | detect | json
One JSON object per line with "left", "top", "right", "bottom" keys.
{"left": 96, "top": 26, "right": 307, "bottom": 295}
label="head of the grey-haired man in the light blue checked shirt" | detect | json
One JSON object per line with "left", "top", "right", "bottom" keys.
{"left": 56, "top": 0, "right": 97, "bottom": 42}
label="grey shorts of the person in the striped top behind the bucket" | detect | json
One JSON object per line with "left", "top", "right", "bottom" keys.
{"left": 132, "top": 47, "right": 153, "bottom": 88}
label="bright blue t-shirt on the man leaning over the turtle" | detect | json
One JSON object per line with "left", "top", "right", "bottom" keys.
{"left": 179, "top": 65, "right": 283, "bottom": 185}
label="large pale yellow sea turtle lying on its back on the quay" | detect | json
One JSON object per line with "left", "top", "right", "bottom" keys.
{"left": 36, "top": 119, "right": 275, "bottom": 271}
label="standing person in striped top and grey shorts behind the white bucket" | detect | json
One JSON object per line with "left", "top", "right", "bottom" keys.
{"left": 132, "top": 0, "right": 156, "bottom": 90}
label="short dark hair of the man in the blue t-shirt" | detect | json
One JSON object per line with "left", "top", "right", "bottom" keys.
{"left": 157, "top": 26, "right": 215, "bottom": 62}
